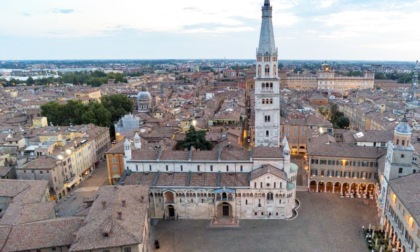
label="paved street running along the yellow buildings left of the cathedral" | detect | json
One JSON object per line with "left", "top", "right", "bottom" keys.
{"left": 56, "top": 161, "right": 108, "bottom": 217}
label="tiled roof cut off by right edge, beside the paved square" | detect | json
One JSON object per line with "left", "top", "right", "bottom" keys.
{"left": 389, "top": 173, "right": 420, "bottom": 224}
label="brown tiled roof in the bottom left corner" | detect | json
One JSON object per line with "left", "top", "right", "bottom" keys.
{"left": 0, "top": 217, "right": 83, "bottom": 251}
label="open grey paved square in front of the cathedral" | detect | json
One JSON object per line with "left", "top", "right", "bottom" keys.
{"left": 151, "top": 192, "right": 378, "bottom": 252}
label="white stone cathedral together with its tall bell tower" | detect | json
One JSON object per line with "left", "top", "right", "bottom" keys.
{"left": 122, "top": 0, "right": 298, "bottom": 220}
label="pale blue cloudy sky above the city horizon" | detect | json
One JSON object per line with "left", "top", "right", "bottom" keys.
{"left": 0, "top": 0, "right": 420, "bottom": 62}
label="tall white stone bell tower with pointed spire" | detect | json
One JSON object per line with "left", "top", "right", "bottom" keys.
{"left": 254, "top": 0, "right": 280, "bottom": 147}
